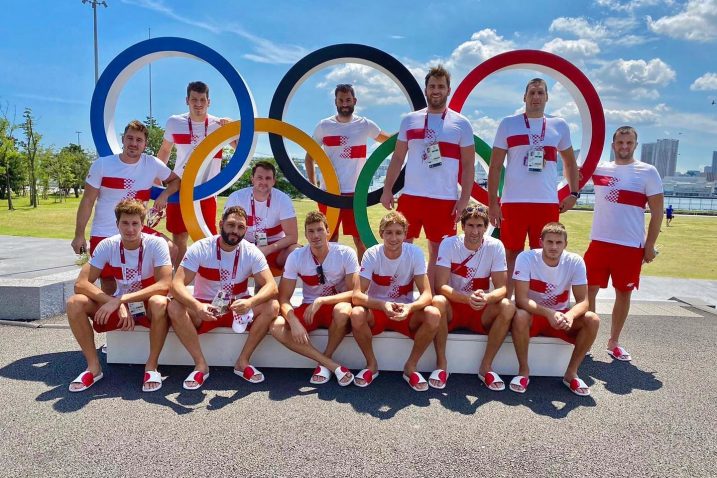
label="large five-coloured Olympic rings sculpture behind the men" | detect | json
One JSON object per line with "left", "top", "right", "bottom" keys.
{"left": 90, "top": 37, "right": 605, "bottom": 246}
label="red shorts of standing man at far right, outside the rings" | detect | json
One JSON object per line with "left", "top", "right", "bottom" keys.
{"left": 585, "top": 241, "right": 645, "bottom": 292}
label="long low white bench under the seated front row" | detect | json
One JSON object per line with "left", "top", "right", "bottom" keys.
{"left": 107, "top": 327, "right": 573, "bottom": 377}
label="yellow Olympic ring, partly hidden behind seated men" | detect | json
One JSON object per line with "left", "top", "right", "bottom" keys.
{"left": 179, "top": 118, "right": 340, "bottom": 241}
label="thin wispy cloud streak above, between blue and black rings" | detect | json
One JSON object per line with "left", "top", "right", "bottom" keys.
{"left": 122, "top": 0, "right": 308, "bottom": 64}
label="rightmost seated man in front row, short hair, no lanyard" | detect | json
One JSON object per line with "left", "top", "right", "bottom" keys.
{"left": 510, "top": 222, "right": 600, "bottom": 397}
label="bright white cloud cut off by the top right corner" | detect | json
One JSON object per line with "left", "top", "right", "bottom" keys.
{"left": 647, "top": 0, "right": 717, "bottom": 42}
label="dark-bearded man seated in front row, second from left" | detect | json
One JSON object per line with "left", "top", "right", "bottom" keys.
{"left": 167, "top": 206, "right": 279, "bottom": 390}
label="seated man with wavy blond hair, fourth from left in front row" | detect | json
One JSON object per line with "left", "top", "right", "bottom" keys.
{"left": 351, "top": 211, "right": 448, "bottom": 392}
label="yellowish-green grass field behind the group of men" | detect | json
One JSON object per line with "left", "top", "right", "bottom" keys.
{"left": 0, "top": 197, "right": 717, "bottom": 279}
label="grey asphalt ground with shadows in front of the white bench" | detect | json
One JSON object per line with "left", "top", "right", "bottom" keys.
{"left": 0, "top": 309, "right": 717, "bottom": 477}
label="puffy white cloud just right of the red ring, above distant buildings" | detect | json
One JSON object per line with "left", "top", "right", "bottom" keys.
{"left": 594, "top": 58, "right": 677, "bottom": 100}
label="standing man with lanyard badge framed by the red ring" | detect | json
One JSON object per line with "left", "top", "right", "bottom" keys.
{"left": 488, "top": 78, "right": 580, "bottom": 298}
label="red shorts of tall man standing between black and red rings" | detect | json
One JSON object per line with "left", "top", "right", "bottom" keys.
{"left": 398, "top": 194, "right": 456, "bottom": 242}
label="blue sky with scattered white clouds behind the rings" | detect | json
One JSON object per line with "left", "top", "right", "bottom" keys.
{"left": 0, "top": 0, "right": 717, "bottom": 171}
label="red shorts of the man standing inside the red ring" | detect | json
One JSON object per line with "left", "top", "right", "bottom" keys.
{"left": 500, "top": 202, "right": 560, "bottom": 251}
